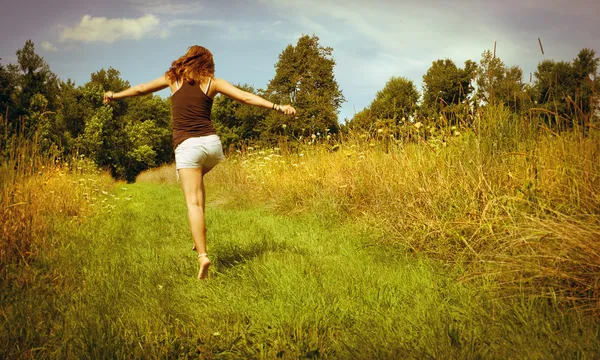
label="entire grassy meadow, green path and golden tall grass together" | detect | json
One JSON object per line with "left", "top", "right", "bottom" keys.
{"left": 0, "top": 108, "right": 600, "bottom": 359}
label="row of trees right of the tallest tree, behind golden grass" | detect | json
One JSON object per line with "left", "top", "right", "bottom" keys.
{"left": 349, "top": 49, "right": 600, "bottom": 130}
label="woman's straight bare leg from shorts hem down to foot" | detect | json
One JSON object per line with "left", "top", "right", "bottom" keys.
{"left": 179, "top": 169, "right": 210, "bottom": 279}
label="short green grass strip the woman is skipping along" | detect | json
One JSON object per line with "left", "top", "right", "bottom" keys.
{"left": 0, "top": 183, "right": 600, "bottom": 359}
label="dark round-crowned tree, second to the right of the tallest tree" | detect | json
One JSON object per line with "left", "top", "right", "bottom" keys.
{"left": 423, "top": 59, "right": 477, "bottom": 119}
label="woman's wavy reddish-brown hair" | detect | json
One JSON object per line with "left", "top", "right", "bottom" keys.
{"left": 165, "top": 45, "right": 215, "bottom": 85}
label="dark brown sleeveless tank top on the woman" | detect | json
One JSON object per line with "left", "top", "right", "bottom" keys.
{"left": 171, "top": 79, "right": 216, "bottom": 149}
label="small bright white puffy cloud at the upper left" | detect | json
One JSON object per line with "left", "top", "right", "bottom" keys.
{"left": 60, "top": 15, "right": 160, "bottom": 44}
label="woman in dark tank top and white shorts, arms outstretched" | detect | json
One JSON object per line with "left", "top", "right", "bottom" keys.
{"left": 104, "top": 45, "right": 296, "bottom": 279}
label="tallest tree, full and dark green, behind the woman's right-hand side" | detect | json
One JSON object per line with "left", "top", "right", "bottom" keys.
{"left": 259, "top": 35, "right": 345, "bottom": 138}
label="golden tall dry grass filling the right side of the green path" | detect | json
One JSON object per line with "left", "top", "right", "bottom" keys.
{"left": 196, "top": 108, "right": 600, "bottom": 309}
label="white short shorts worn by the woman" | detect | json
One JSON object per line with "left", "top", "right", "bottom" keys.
{"left": 175, "top": 135, "right": 224, "bottom": 181}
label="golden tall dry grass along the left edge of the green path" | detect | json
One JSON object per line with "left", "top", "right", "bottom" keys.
{"left": 0, "top": 116, "right": 113, "bottom": 279}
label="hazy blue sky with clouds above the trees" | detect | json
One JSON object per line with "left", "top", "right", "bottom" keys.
{"left": 0, "top": 0, "right": 600, "bottom": 122}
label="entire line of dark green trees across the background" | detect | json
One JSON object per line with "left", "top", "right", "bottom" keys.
{"left": 0, "top": 35, "right": 600, "bottom": 181}
